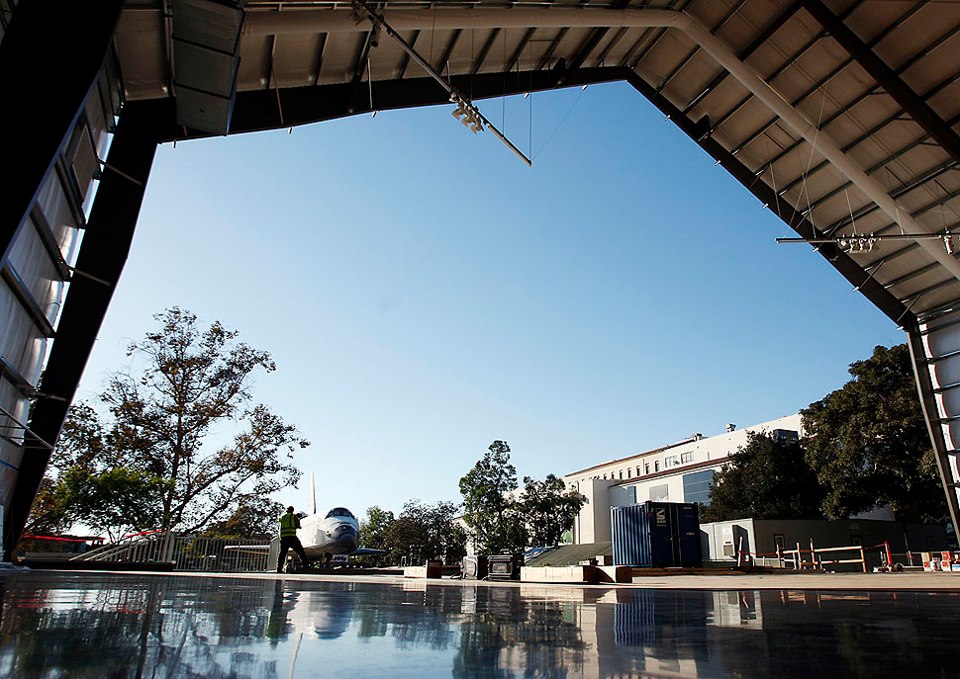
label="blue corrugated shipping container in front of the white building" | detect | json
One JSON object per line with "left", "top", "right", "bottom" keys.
{"left": 610, "top": 500, "right": 703, "bottom": 568}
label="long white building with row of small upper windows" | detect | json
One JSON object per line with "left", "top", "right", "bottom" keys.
{"left": 563, "top": 413, "right": 803, "bottom": 544}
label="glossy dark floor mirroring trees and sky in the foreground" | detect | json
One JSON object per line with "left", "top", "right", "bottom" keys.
{"left": 0, "top": 571, "right": 960, "bottom": 679}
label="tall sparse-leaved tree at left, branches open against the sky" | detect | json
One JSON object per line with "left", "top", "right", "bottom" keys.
{"left": 44, "top": 307, "right": 309, "bottom": 532}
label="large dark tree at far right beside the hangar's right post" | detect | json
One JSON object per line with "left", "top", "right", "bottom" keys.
{"left": 801, "top": 344, "right": 947, "bottom": 520}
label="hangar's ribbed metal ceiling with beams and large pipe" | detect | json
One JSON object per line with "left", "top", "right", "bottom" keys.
{"left": 116, "top": 0, "right": 960, "bottom": 323}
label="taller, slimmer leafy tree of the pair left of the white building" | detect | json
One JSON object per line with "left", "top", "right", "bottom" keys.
{"left": 460, "top": 441, "right": 527, "bottom": 554}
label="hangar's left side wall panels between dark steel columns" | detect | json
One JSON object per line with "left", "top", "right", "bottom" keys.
{"left": 0, "top": 38, "right": 121, "bottom": 548}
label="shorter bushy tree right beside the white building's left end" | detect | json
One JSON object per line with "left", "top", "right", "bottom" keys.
{"left": 520, "top": 474, "right": 587, "bottom": 546}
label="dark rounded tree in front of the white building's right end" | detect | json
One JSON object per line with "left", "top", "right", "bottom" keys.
{"left": 703, "top": 432, "right": 823, "bottom": 521}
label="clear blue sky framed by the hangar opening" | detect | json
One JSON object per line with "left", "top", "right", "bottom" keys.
{"left": 71, "top": 84, "right": 906, "bottom": 515}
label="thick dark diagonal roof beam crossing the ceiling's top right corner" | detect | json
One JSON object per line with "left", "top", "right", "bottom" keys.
{"left": 801, "top": 0, "right": 960, "bottom": 165}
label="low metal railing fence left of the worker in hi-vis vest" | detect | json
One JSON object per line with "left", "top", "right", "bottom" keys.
{"left": 70, "top": 531, "right": 276, "bottom": 573}
